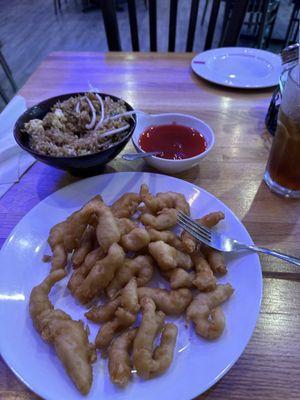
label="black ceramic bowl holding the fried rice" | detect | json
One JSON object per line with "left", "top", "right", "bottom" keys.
{"left": 14, "top": 93, "right": 136, "bottom": 175}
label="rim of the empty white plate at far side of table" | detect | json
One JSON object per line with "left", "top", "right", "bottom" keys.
{"left": 190, "top": 46, "right": 281, "bottom": 90}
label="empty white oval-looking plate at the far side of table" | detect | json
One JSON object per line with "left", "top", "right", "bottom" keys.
{"left": 192, "top": 47, "right": 282, "bottom": 89}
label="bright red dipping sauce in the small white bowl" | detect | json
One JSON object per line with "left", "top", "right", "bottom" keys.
{"left": 139, "top": 124, "right": 207, "bottom": 160}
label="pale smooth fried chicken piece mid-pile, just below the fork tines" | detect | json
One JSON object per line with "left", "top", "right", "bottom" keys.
{"left": 148, "top": 240, "right": 193, "bottom": 270}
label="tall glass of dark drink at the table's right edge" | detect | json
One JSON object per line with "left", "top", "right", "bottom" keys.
{"left": 264, "top": 65, "right": 300, "bottom": 198}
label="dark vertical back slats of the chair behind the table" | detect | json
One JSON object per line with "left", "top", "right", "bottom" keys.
{"left": 101, "top": 0, "right": 248, "bottom": 52}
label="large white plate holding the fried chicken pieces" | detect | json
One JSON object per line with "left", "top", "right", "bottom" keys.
{"left": 0, "top": 172, "right": 262, "bottom": 400}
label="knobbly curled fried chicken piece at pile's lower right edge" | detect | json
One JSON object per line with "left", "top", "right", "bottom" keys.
{"left": 186, "top": 283, "right": 233, "bottom": 340}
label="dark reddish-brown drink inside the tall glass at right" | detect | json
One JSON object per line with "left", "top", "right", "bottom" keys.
{"left": 268, "top": 110, "right": 300, "bottom": 190}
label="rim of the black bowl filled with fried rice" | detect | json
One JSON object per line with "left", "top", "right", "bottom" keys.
{"left": 13, "top": 91, "right": 137, "bottom": 161}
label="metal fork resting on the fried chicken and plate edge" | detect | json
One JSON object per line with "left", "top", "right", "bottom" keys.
{"left": 177, "top": 211, "right": 300, "bottom": 267}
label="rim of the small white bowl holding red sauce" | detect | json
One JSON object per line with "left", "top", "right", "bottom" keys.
{"left": 131, "top": 113, "right": 215, "bottom": 164}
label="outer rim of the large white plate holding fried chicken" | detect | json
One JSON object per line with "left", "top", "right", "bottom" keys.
{"left": 0, "top": 171, "right": 263, "bottom": 400}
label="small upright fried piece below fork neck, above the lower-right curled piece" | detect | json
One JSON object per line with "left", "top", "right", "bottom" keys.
{"left": 192, "top": 253, "right": 217, "bottom": 292}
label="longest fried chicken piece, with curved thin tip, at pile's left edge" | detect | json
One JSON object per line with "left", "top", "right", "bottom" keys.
{"left": 29, "top": 269, "right": 96, "bottom": 394}
